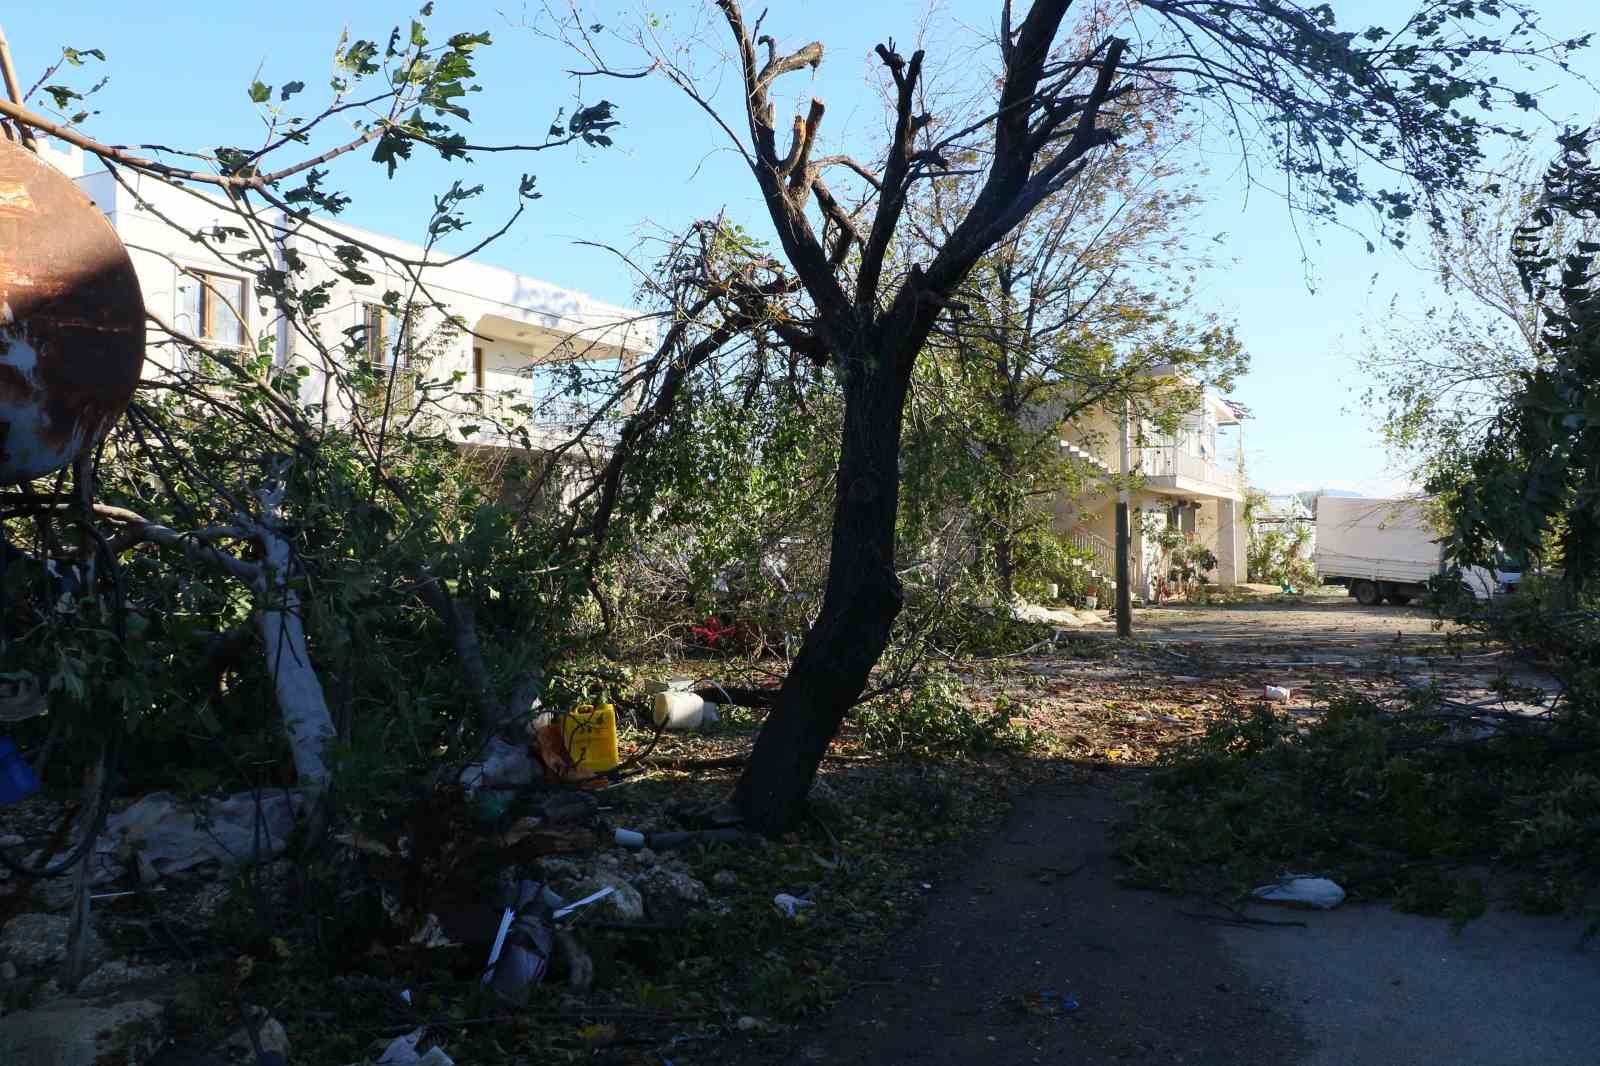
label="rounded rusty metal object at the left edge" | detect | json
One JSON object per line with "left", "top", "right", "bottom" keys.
{"left": 0, "top": 141, "right": 144, "bottom": 485}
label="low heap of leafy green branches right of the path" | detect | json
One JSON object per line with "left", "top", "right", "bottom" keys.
{"left": 1123, "top": 693, "right": 1600, "bottom": 922}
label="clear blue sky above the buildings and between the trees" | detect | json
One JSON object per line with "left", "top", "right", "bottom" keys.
{"left": 3, "top": 0, "right": 1600, "bottom": 493}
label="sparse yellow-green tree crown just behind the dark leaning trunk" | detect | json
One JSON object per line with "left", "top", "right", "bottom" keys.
{"left": 902, "top": 95, "right": 1245, "bottom": 600}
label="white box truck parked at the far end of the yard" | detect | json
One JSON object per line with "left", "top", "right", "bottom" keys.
{"left": 1312, "top": 496, "right": 1522, "bottom": 607}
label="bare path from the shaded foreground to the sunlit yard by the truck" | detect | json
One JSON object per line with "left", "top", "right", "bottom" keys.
{"left": 722, "top": 599, "right": 1600, "bottom": 1066}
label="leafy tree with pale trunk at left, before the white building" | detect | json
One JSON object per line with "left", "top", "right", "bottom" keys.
{"left": 0, "top": 5, "right": 662, "bottom": 809}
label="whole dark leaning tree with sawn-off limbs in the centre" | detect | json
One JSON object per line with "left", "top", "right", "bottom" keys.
{"left": 576, "top": 0, "right": 1573, "bottom": 831}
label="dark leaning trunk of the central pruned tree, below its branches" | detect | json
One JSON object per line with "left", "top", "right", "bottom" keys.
{"left": 734, "top": 348, "right": 909, "bottom": 832}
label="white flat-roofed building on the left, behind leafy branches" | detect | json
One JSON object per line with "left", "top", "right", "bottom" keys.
{"left": 43, "top": 142, "right": 656, "bottom": 457}
